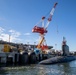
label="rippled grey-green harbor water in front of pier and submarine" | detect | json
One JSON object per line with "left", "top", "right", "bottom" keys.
{"left": 0, "top": 60, "right": 76, "bottom": 75}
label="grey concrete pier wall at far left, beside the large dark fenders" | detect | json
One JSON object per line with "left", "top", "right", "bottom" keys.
{"left": 0, "top": 52, "right": 19, "bottom": 63}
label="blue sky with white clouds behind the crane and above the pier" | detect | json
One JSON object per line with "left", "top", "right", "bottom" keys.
{"left": 0, "top": 0, "right": 76, "bottom": 51}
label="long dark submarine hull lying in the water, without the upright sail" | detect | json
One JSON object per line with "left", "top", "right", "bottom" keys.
{"left": 39, "top": 56, "right": 76, "bottom": 65}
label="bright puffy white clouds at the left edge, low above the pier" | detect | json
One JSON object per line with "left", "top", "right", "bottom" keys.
{"left": 0, "top": 27, "right": 22, "bottom": 42}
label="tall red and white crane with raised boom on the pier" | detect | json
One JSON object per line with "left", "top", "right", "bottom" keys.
{"left": 32, "top": 3, "right": 58, "bottom": 50}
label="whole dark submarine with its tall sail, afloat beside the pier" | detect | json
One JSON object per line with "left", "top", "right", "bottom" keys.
{"left": 39, "top": 37, "right": 76, "bottom": 65}
